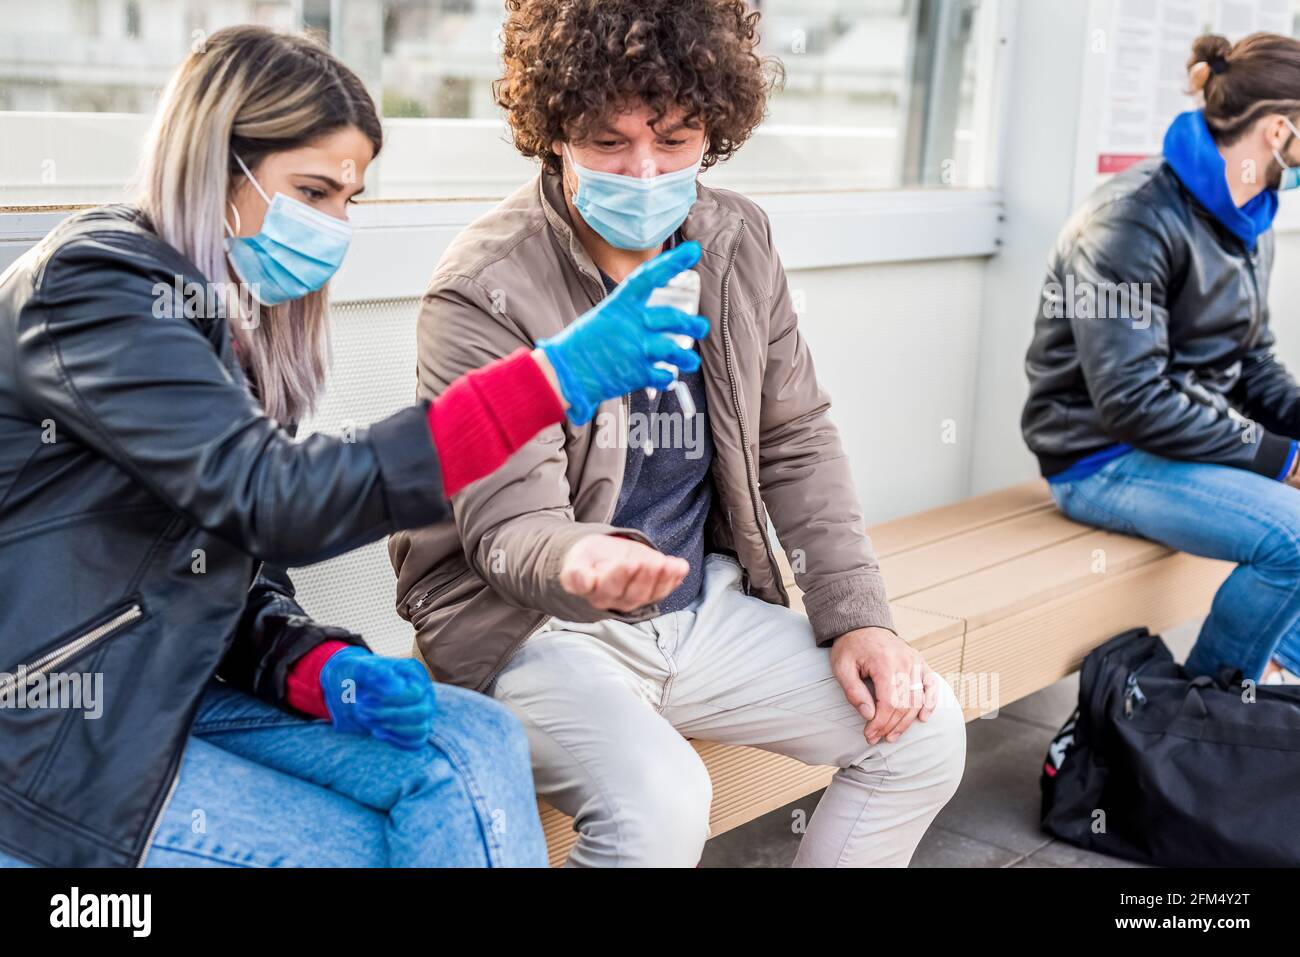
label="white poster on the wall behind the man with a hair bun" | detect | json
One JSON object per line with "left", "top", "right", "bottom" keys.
{"left": 1095, "top": 0, "right": 1295, "bottom": 176}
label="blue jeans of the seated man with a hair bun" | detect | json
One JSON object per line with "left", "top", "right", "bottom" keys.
{"left": 1052, "top": 451, "right": 1300, "bottom": 679}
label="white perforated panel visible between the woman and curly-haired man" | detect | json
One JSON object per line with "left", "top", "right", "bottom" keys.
{"left": 291, "top": 299, "right": 420, "bottom": 655}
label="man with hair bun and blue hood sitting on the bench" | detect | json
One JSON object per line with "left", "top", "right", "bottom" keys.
{"left": 1023, "top": 34, "right": 1300, "bottom": 683}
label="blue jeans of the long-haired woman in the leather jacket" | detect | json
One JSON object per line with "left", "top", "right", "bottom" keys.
{"left": 0, "top": 683, "right": 546, "bottom": 867}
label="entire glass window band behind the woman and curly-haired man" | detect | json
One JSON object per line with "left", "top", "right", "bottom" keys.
{"left": 0, "top": 0, "right": 996, "bottom": 207}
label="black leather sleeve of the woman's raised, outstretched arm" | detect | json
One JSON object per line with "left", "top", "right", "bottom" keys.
{"left": 16, "top": 231, "right": 450, "bottom": 567}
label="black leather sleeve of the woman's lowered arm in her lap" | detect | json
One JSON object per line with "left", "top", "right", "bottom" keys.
{"left": 217, "top": 564, "right": 367, "bottom": 710}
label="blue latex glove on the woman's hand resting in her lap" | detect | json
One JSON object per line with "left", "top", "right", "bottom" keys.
{"left": 321, "top": 648, "right": 436, "bottom": 750}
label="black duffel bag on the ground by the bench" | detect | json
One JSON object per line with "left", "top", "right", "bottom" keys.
{"left": 1041, "top": 628, "right": 1300, "bottom": 867}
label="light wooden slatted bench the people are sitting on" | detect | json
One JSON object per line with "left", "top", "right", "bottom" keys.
{"left": 540, "top": 481, "right": 1232, "bottom": 865}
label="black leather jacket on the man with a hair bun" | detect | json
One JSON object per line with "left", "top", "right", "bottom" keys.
{"left": 1022, "top": 159, "right": 1300, "bottom": 477}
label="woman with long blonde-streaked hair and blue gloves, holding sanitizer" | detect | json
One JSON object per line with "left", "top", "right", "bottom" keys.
{"left": 0, "top": 27, "right": 707, "bottom": 866}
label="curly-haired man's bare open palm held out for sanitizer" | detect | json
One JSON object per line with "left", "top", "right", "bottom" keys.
{"left": 560, "top": 534, "right": 690, "bottom": 611}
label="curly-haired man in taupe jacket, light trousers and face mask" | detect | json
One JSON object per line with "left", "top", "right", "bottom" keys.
{"left": 390, "top": 0, "right": 966, "bottom": 866}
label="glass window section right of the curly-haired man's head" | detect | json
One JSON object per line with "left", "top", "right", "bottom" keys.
{"left": 716, "top": 0, "right": 977, "bottom": 191}
